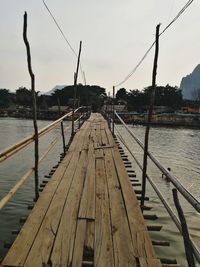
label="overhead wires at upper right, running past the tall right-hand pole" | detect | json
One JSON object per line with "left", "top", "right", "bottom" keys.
{"left": 115, "top": 0, "right": 194, "bottom": 87}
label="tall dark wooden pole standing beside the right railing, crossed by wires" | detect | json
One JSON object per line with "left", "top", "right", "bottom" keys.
{"left": 141, "top": 24, "right": 160, "bottom": 206}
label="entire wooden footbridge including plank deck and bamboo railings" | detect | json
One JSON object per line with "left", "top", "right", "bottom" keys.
{"left": 0, "top": 108, "right": 200, "bottom": 267}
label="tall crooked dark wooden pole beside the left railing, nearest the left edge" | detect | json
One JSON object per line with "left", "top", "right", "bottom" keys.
{"left": 23, "top": 12, "right": 39, "bottom": 200}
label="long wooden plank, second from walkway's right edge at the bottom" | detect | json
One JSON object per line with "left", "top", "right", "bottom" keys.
{"left": 104, "top": 149, "right": 136, "bottom": 266}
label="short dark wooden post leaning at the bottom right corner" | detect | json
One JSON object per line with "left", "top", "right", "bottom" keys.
{"left": 172, "top": 188, "right": 195, "bottom": 267}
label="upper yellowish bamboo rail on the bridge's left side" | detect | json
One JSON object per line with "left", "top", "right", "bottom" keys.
{"left": 0, "top": 107, "right": 81, "bottom": 163}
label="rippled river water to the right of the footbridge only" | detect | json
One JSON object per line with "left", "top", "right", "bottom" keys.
{"left": 117, "top": 125, "right": 200, "bottom": 266}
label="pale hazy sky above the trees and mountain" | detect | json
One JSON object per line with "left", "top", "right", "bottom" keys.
{"left": 0, "top": 0, "right": 200, "bottom": 92}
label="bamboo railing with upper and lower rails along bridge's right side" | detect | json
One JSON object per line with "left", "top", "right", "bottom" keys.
{"left": 115, "top": 112, "right": 200, "bottom": 263}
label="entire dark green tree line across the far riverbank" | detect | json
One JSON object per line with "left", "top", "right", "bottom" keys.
{"left": 0, "top": 84, "right": 199, "bottom": 111}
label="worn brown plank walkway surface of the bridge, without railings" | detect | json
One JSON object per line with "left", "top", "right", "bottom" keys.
{"left": 2, "top": 113, "right": 162, "bottom": 267}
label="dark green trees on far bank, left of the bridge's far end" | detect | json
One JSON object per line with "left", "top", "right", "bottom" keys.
{"left": 0, "top": 84, "right": 106, "bottom": 111}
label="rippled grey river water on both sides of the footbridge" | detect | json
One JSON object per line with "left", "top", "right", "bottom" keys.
{"left": 0, "top": 118, "right": 200, "bottom": 266}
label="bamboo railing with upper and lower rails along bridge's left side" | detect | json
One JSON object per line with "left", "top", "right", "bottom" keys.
{"left": 0, "top": 107, "right": 88, "bottom": 210}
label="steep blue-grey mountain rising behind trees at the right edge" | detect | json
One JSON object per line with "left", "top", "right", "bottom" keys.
{"left": 180, "top": 64, "right": 200, "bottom": 100}
